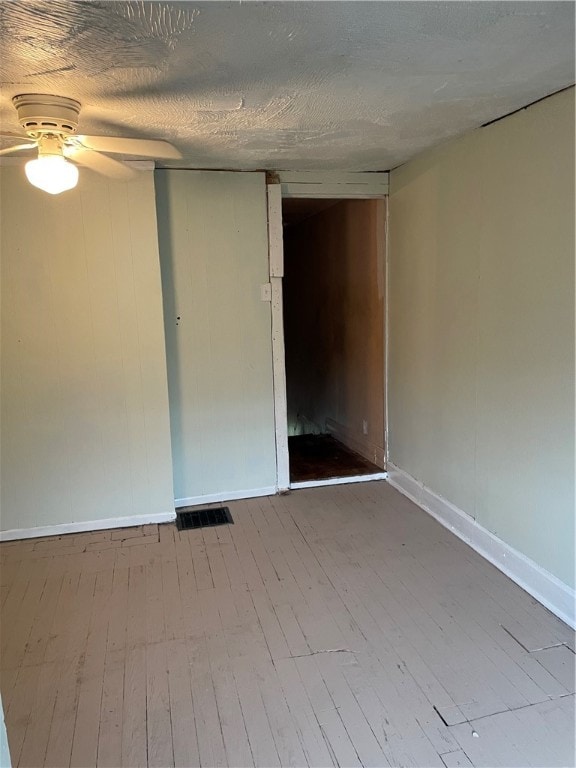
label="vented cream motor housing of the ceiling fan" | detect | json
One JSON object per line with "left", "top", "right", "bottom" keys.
{"left": 12, "top": 93, "right": 80, "bottom": 139}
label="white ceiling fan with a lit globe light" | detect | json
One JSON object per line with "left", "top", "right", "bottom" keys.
{"left": 0, "top": 93, "right": 181, "bottom": 195}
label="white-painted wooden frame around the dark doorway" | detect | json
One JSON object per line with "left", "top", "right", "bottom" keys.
{"left": 266, "top": 171, "right": 388, "bottom": 492}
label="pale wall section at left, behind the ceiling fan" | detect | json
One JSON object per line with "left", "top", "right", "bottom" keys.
{"left": 0, "top": 165, "right": 174, "bottom": 530}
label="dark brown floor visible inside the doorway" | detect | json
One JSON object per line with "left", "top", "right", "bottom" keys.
{"left": 288, "top": 435, "right": 382, "bottom": 483}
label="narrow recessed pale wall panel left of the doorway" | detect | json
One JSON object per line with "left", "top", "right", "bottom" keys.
{"left": 156, "top": 171, "right": 276, "bottom": 503}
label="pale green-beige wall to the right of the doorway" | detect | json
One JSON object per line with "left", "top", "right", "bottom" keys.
{"left": 389, "top": 89, "right": 574, "bottom": 585}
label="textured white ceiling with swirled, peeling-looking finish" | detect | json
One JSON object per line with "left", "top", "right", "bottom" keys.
{"left": 0, "top": 0, "right": 574, "bottom": 171}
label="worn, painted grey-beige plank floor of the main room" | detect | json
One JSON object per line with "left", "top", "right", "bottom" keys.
{"left": 1, "top": 482, "right": 575, "bottom": 768}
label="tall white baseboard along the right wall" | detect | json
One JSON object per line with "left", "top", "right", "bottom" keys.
{"left": 388, "top": 462, "right": 576, "bottom": 628}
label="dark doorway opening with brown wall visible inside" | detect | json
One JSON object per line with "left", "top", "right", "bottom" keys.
{"left": 282, "top": 198, "right": 386, "bottom": 487}
